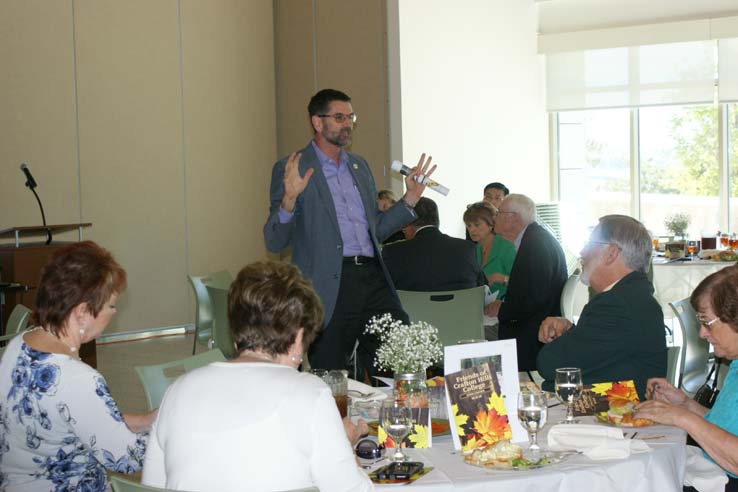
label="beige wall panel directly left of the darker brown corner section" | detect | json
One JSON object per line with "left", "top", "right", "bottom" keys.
{"left": 182, "top": 0, "right": 276, "bottom": 275}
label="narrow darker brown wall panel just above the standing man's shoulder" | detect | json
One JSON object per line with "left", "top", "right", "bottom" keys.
{"left": 274, "top": 0, "right": 317, "bottom": 157}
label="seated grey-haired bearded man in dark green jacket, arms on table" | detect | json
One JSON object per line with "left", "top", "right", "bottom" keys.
{"left": 537, "top": 215, "right": 666, "bottom": 400}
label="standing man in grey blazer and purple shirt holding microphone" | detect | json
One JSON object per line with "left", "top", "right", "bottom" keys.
{"left": 264, "top": 89, "right": 435, "bottom": 370}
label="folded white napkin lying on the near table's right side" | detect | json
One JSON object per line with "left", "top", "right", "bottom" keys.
{"left": 548, "top": 424, "right": 651, "bottom": 460}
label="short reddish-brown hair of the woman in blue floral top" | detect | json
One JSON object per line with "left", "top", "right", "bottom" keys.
{"left": 32, "top": 241, "right": 126, "bottom": 336}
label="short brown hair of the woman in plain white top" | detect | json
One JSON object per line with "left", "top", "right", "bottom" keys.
{"left": 228, "top": 261, "right": 323, "bottom": 356}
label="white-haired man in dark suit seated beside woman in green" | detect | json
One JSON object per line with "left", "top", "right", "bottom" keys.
{"left": 485, "top": 194, "right": 567, "bottom": 371}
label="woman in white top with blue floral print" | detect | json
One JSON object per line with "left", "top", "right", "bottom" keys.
{"left": 0, "top": 241, "right": 154, "bottom": 492}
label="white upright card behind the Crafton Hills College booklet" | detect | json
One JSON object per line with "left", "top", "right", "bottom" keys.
{"left": 444, "top": 340, "right": 528, "bottom": 450}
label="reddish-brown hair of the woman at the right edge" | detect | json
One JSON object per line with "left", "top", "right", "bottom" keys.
{"left": 689, "top": 265, "right": 738, "bottom": 332}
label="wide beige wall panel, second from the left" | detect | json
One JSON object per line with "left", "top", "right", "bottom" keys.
{"left": 75, "top": 0, "right": 189, "bottom": 331}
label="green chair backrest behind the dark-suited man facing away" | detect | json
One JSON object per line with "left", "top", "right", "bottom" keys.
{"left": 397, "top": 286, "right": 484, "bottom": 346}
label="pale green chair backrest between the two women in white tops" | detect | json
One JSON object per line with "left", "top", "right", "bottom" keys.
{"left": 134, "top": 348, "right": 225, "bottom": 410}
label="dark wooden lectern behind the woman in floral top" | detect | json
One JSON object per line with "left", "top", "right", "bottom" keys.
{"left": 0, "top": 222, "right": 97, "bottom": 367}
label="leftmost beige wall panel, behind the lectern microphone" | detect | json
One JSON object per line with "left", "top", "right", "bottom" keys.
{"left": 0, "top": 0, "right": 79, "bottom": 239}
